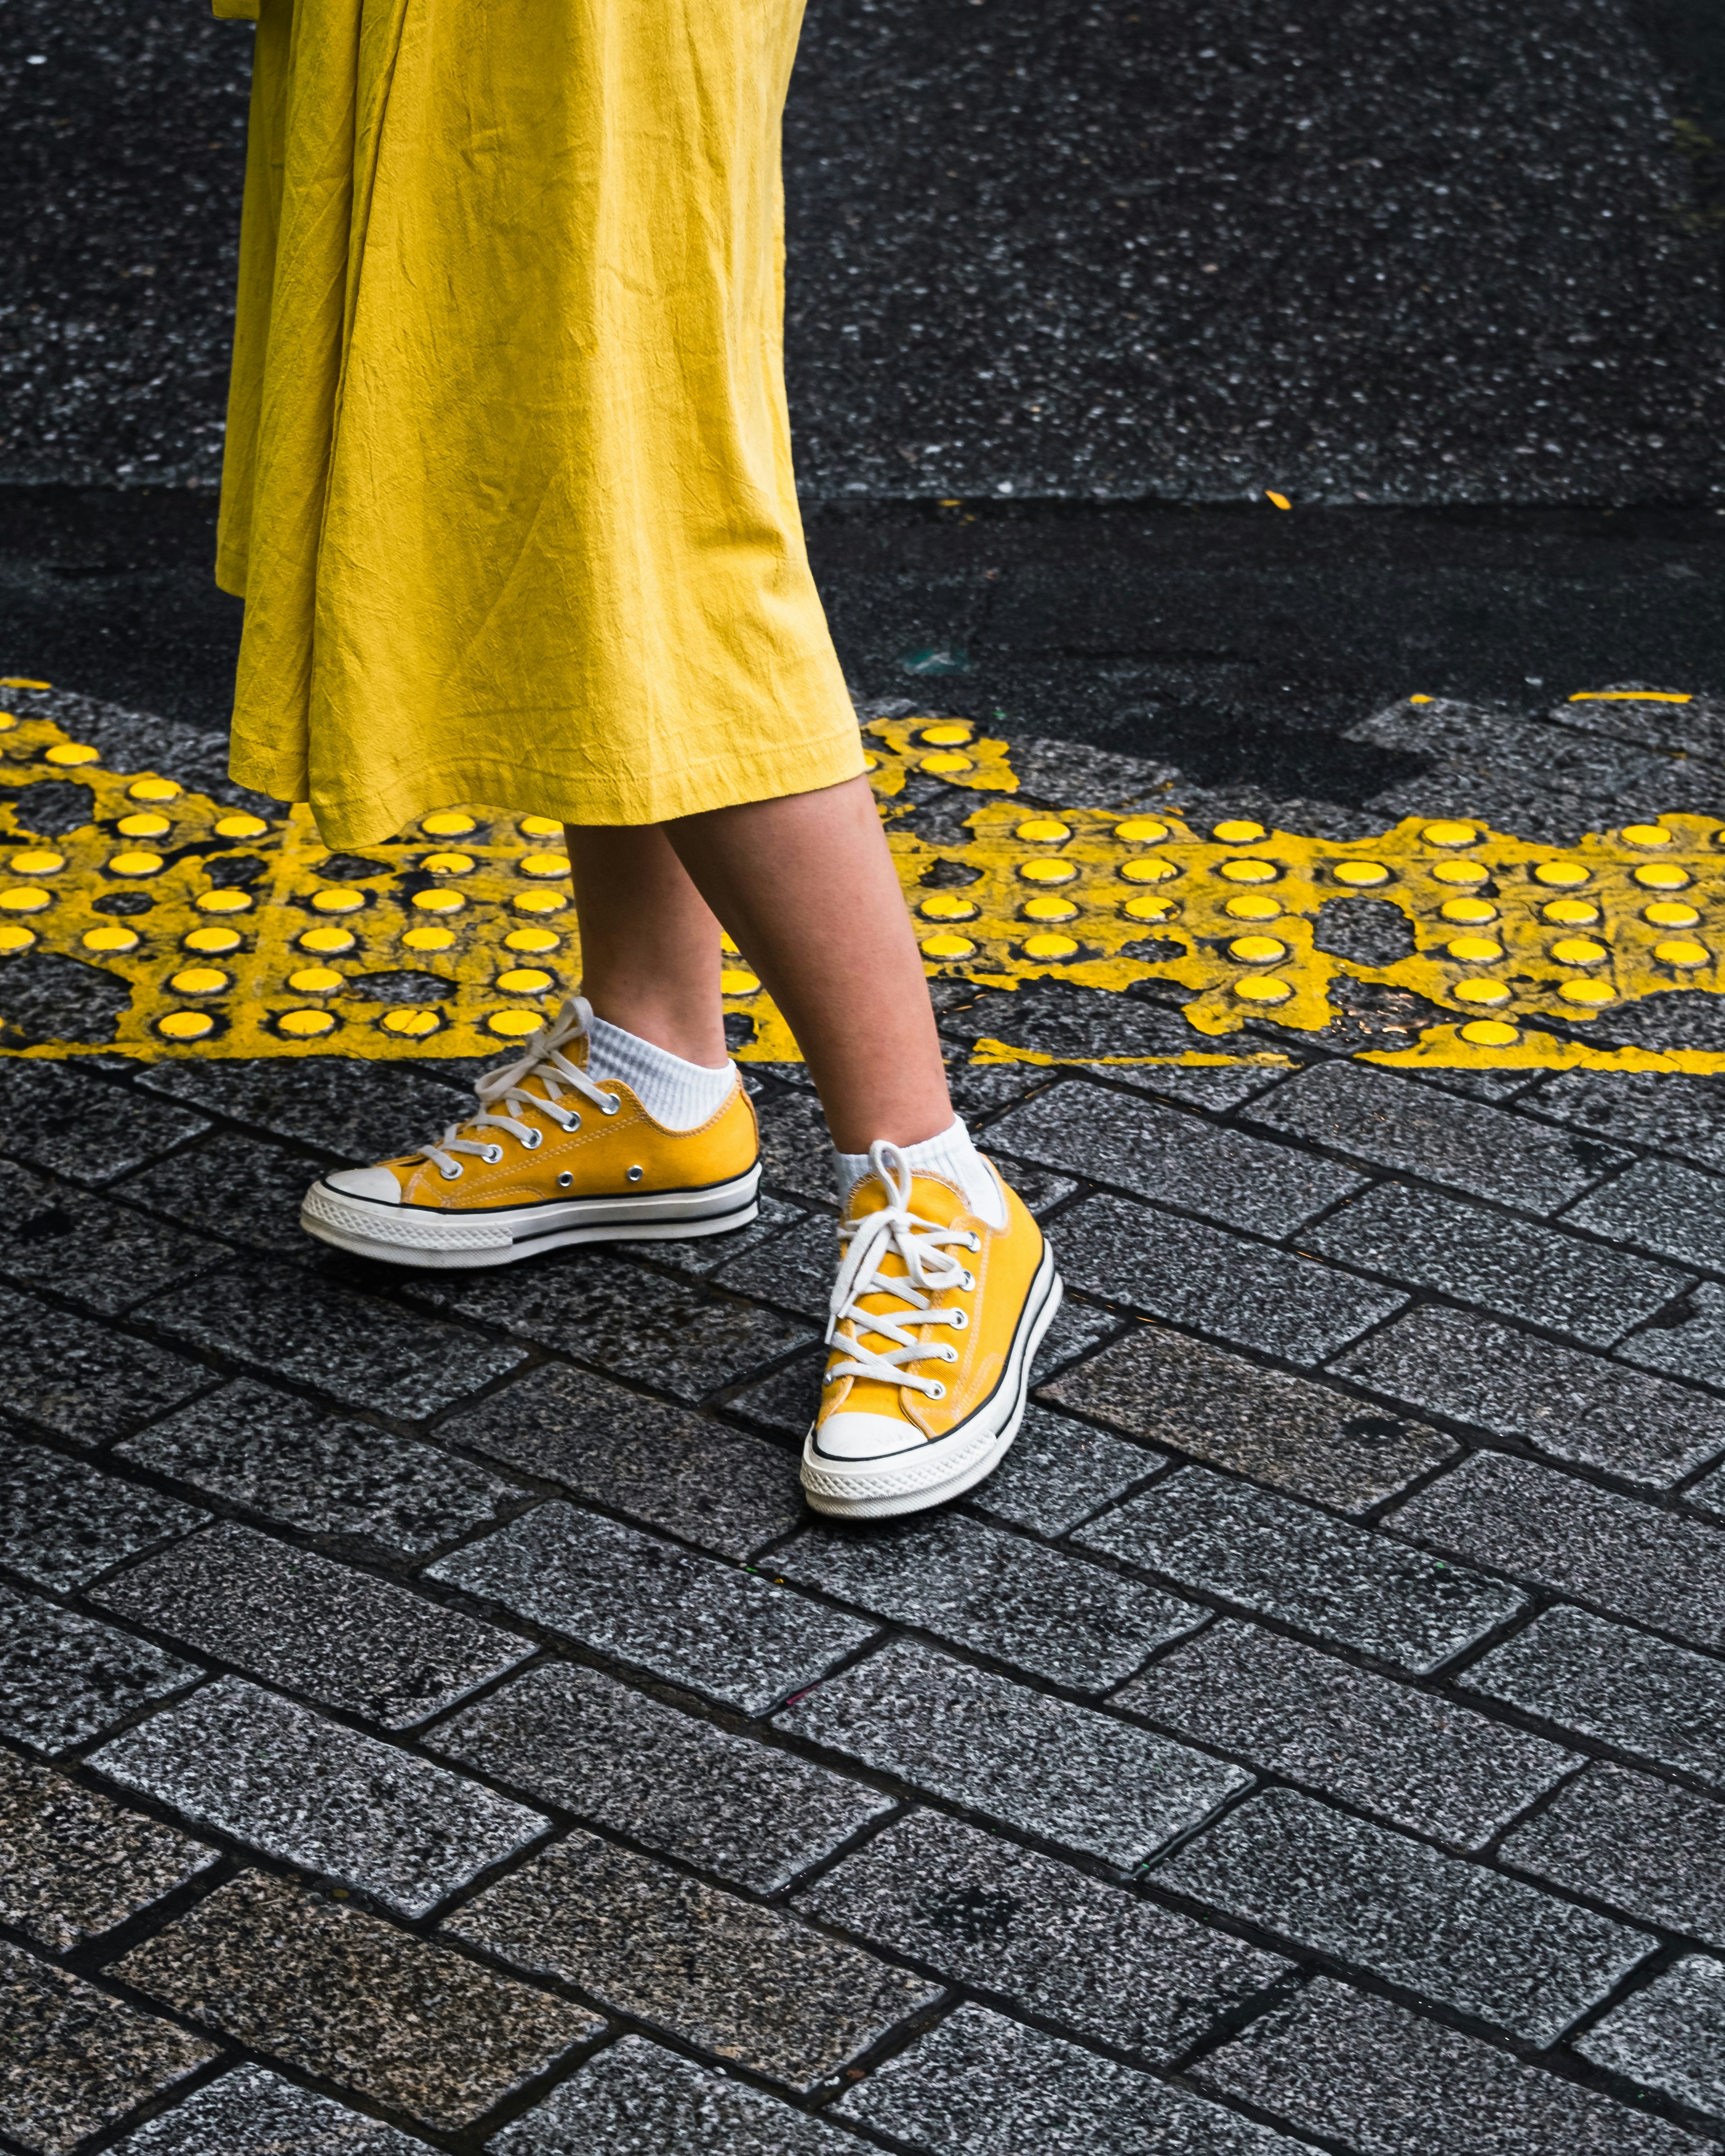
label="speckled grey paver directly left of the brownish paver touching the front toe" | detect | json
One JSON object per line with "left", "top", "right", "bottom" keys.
{"left": 117, "top": 1378, "right": 526, "bottom": 1556}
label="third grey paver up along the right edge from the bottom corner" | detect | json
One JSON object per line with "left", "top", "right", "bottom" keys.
{"left": 1464, "top": 1608, "right": 1725, "bottom": 1790}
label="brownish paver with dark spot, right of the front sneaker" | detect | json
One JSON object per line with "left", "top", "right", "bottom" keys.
{"left": 1048, "top": 1326, "right": 1458, "bottom": 1511}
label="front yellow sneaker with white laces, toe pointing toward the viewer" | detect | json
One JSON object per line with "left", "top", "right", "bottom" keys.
{"left": 802, "top": 1143, "right": 1061, "bottom": 1520}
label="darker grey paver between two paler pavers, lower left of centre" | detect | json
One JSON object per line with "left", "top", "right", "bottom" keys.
{"left": 425, "top": 1662, "right": 891, "bottom": 1893}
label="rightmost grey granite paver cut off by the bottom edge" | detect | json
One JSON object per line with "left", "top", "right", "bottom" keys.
{"left": 1193, "top": 1977, "right": 1703, "bottom": 2156}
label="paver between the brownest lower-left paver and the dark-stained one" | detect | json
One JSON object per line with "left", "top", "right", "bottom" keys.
{"left": 444, "top": 1830, "right": 938, "bottom": 2089}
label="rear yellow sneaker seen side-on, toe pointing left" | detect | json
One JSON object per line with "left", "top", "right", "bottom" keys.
{"left": 300, "top": 996, "right": 761, "bottom": 1268}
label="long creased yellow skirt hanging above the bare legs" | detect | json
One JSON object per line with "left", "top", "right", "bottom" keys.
{"left": 218, "top": 0, "right": 862, "bottom": 845}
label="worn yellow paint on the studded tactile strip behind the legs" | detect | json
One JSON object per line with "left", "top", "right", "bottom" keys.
{"left": 0, "top": 684, "right": 1725, "bottom": 1072}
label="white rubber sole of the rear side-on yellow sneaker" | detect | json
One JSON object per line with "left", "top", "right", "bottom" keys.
{"left": 300, "top": 1164, "right": 761, "bottom": 1272}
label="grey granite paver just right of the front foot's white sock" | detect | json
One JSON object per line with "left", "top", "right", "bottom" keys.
{"left": 988, "top": 1082, "right": 1365, "bottom": 1235}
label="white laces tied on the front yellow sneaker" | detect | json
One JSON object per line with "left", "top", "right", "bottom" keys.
{"left": 826, "top": 1138, "right": 983, "bottom": 1399}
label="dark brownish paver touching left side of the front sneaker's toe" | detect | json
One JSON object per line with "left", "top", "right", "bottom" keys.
{"left": 438, "top": 1365, "right": 804, "bottom": 1556}
